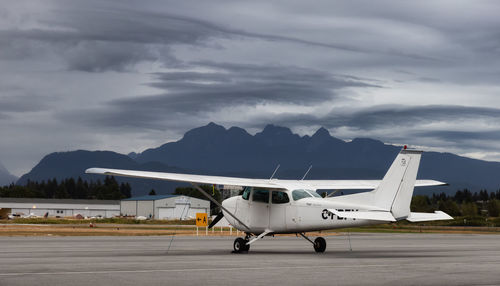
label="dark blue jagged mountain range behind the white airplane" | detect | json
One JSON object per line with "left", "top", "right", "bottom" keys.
{"left": 17, "top": 123, "right": 500, "bottom": 198}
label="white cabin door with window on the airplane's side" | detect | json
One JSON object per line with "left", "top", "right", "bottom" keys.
{"left": 249, "top": 188, "right": 270, "bottom": 232}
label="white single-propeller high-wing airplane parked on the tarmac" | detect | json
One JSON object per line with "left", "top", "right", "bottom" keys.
{"left": 85, "top": 146, "right": 453, "bottom": 252}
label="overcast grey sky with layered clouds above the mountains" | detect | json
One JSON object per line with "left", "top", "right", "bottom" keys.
{"left": 0, "top": 0, "right": 500, "bottom": 176}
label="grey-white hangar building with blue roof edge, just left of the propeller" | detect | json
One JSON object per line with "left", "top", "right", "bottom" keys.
{"left": 120, "top": 195, "right": 210, "bottom": 219}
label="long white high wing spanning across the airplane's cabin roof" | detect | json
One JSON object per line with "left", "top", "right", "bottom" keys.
{"left": 85, "top": 168, "right": 446, "bottom": 190}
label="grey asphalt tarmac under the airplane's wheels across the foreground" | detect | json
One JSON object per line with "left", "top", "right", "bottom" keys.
{"left": 0, "top": 234, "right": 500, "bottom": 286}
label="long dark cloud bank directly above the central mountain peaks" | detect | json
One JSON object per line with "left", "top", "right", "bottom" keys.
{"left": 60, "top": 62, "right": 379, "bottom": 129}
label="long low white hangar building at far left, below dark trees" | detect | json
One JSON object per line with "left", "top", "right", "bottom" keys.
{"left": 0, "top": 198, "right": 120, "bottom": 218}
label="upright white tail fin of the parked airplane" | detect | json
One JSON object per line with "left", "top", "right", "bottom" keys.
{"left": 373, "top": 149, "right": 422, "bottom": 220}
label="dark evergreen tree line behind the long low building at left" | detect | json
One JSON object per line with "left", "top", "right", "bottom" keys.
{"left": 0, "top": 176, "right": 132, "bottom": 200}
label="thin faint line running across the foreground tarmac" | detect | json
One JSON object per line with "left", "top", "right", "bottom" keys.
{"left": 0, "top": 264, "right": 390, "bottom": 277}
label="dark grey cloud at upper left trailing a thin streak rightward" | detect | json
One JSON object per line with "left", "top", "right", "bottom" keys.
{"left": 0, "top": 4, "right": 437, "bottom": 72}
